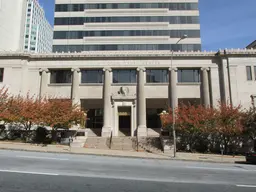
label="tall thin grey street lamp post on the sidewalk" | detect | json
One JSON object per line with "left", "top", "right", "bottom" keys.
{"left": 170, "top": 35, "right": 188, "bottom": 157}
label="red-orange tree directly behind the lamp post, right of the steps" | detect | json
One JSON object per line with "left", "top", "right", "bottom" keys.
{"left": 160, "top": 104, "right": 217, "bottom": 152}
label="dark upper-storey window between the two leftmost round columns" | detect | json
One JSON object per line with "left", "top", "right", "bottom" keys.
{"left": 50, "top": 70, "right": 72, "bottom": 83}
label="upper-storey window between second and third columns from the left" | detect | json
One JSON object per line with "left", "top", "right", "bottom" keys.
{"left": 81, "top": 69, "right": 103, "bottom": 83}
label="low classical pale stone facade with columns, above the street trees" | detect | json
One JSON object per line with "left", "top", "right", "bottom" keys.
{"left": 0, "top": 50, "right": 256, "bottom": 137}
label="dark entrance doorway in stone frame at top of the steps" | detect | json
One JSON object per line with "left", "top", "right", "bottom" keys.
{"left": 118, "top": 107, "right": 131, "bottom": 136}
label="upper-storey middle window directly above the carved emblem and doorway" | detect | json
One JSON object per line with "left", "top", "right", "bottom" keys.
{"left": 113, "top": 69, "right": 136, "bottom": 83}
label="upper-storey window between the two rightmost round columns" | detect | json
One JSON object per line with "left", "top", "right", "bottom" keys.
{"left": 178, "top": 69, "right": 200, "bottom": 83}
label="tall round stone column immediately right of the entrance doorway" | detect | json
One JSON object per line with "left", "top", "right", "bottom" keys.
{"left": 137, "top": 68, "right": 147, "bottom": 137}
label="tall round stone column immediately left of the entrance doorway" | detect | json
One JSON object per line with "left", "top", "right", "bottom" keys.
{"left": 101, "top": 68, "right": 112, "bottom": 137}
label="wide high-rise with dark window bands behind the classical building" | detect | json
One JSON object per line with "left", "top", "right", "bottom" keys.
{"left": 53, "top": 0, "right": 201, "bottom": 52}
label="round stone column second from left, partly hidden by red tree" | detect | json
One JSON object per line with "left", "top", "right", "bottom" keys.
{"left": 71, "top": 68, "right": 81, "bottom": 106}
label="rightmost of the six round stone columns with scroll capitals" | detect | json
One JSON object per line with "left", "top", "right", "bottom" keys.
{"left": 201, "top": 68, "right": 210, "bottom": 107}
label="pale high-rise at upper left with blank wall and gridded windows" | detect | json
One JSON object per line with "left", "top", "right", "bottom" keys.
{"left": 0, "top": 0, "right": 53, "bottom": 53}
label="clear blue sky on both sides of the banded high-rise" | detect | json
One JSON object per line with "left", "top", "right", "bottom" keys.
{"left": 39, "top": 0, "right": 256, "bottom": 51}
